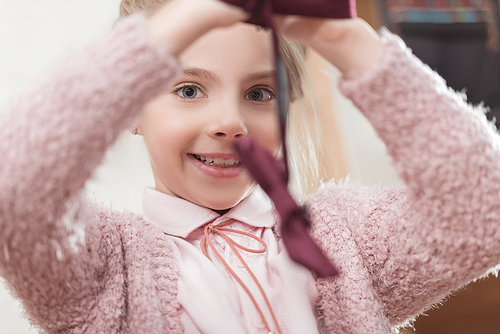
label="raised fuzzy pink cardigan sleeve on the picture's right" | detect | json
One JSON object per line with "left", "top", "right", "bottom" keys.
{"left": 311, "top": 33, "right": 500, "bottom": 325}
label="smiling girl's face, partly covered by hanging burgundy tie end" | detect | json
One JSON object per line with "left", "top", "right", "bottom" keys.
{"left": 138, "top": 23, "right": 280, "bottom": 210}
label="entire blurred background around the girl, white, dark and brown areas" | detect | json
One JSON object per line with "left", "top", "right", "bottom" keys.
{"left": 0, "top": 0, "right": 500, "bottom": 334}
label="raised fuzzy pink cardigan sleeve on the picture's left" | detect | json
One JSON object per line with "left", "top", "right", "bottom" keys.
{"left": 0, "top": 15, "right": 178, "bottom": 332}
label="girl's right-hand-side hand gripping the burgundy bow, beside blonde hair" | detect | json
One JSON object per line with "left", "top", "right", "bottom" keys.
{"left": 275, "top": 15, "right": 384, "bottom": 75}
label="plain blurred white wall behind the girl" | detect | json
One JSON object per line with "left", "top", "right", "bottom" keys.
{"left": 0, "top": 0, "right": 395, "bottom": 334}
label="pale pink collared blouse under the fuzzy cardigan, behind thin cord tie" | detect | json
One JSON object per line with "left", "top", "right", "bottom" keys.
{"left": 143, "top": 188, "right": 318, "bottom": 334}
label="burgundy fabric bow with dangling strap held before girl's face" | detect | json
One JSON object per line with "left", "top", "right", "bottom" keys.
{"left": 222, "top": 0, "right": 356, "bottom": 277}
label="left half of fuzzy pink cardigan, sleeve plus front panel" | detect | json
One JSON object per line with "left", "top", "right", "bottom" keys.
{"left": 0, "top": 16, "right": 182, "bottom": 333}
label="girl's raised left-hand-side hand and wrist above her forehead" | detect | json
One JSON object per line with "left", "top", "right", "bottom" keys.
{"left": 147, "top": 0, "right": 250, "bottom": 57}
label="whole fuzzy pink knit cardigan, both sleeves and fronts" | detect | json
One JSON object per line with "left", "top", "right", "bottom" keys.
{"left": 0, "top": 16, "right": 500, "bottom": 333}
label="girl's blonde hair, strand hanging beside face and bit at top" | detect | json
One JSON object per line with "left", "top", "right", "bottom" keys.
{"left": 120, "top": 0, "right": 321, "bottom": 198}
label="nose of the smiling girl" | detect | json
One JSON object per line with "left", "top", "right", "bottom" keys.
{"left": 208, "top": 103, "right": 248, "bottom": 141}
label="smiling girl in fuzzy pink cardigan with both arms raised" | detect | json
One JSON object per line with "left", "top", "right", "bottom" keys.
{"left": 0, "top": 0, "right": 500, "bottom": 333}
